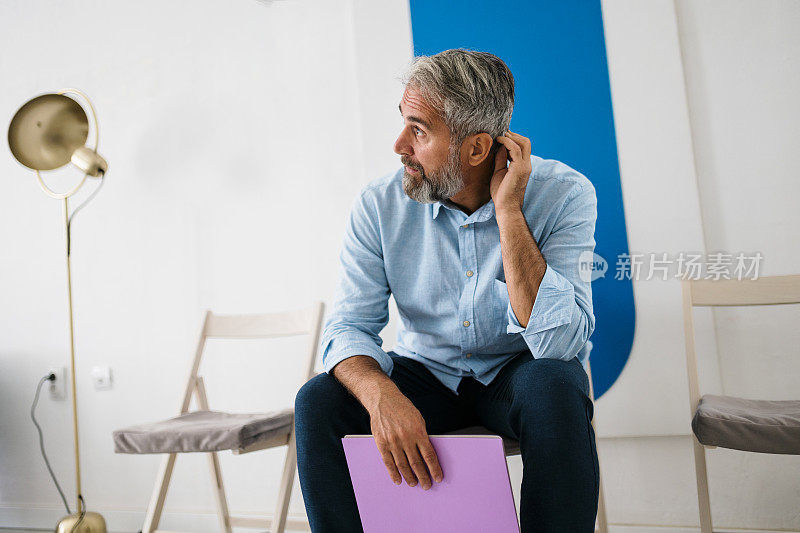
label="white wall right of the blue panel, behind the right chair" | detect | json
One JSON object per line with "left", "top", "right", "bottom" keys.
{"left": 597, "top": 0, "right": 800, "bottom": 531}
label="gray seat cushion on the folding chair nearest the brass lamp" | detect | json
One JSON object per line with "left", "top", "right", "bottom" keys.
{"left": 114, "top": 408, "right": 294, "bottom": 453}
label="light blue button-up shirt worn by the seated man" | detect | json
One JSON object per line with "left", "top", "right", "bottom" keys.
{"left": 320, "top": 156, "right": 597, "bottom": 393}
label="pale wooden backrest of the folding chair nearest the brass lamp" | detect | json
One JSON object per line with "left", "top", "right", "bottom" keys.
{"left": 180, "top": 302, "right": 325, "bottom": 414}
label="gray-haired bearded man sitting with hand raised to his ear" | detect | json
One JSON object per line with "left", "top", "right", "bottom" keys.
{"left": 295, "top": 50, "right": 598, "bottom": 533}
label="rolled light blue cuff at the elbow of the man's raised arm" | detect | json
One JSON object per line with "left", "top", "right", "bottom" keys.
{"left": 506, "top": 265, "right": 575, "bottom": 335}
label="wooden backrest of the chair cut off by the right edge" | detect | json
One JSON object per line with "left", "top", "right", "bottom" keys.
{"left": 682, "top": 274, "right": 800, "bottom": 416}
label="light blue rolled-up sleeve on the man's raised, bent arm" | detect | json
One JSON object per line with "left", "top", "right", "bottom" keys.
{"left": 506, "top": 182, "right": 597, "bottom": 360}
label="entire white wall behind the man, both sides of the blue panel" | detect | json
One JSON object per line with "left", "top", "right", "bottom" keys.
{"left": 0, "top": 0, "right": 800, "bottom": 531}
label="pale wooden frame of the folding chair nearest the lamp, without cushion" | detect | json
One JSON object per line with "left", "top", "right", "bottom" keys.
{"left": 128, "top": 302, "right": 325, "bottom": 533}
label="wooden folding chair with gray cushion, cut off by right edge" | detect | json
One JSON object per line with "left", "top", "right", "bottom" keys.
{"left": 682, "top": 275, "right": 800, "bottom": 533}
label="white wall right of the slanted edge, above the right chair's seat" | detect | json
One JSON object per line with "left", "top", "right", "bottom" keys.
{"left": 677, "top": 0, "right": 800, "bottom": 402}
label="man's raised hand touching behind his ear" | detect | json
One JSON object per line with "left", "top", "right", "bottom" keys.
{"left": 489, "top": 131, "right": 531, "bottom": 211}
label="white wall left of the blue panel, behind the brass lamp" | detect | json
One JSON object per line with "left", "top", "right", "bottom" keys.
{"left": 0, "top": 0, "right": 365, "bottom": 531}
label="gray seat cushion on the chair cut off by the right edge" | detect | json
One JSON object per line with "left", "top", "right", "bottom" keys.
{"left": 692, "top": 394, "right": 800, "bottom": 455}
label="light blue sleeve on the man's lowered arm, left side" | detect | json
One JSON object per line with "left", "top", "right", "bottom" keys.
{"left": 320, "top": 189, "right": 393, "bottom": 374}
